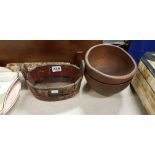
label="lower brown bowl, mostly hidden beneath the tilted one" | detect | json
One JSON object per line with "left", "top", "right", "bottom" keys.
{"left": 85, "top": 73, "right": 130, "bottom": 96}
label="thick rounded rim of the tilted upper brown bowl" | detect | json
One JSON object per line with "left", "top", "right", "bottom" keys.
{"left": 85, "top": 43, "right": 137, "bottom": 80}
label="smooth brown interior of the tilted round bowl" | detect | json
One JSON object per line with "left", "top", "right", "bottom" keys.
{"left": 88, "top": 45, "right": 135, "bottom": 76}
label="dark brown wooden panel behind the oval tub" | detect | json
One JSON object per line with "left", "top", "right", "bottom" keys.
{"left": 0, "top": 40, "right": 102, "bottom": 66}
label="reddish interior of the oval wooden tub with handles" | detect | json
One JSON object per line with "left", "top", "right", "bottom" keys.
{"left": 28, "top": 65, "right": 81, "bottom": 89}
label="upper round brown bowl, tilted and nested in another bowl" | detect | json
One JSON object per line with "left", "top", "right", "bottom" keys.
{"left": 85, "top": 44, "right": 137, "bottom": 84}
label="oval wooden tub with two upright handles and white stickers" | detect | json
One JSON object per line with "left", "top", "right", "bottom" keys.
{"left": 21, "top": 61, "right": 84, "bottom": 101}
